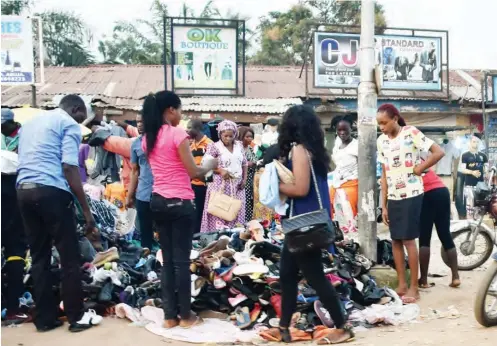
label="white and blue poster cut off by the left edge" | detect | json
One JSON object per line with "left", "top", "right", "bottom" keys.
{"left": 1, "top": 16, "right": 35, "bottom": 85}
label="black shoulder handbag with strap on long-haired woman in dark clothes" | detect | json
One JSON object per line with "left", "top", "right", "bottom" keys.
{"left": 281, "top": 152, "right": 336, "bottom": 253}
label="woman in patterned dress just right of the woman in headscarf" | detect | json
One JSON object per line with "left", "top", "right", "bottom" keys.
{"left": 238, "top": 126, "right": 257, "bottom": 222}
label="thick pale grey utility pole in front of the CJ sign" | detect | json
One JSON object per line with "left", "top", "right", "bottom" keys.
{"left": 357, "top": 0, "right": 378, "bottom": 260}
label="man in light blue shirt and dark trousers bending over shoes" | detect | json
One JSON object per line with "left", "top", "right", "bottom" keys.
{"left": 17, "top": 95, "right": 102, "bottom": 332}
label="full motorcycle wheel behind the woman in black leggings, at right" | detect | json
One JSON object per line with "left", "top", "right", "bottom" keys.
{"left": 440, "top": 227, "right": 494, "bottom": 271}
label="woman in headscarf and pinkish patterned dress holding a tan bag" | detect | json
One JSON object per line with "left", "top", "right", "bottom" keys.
{"left": 200, "top": 120, "right": 247, "bottom": 232}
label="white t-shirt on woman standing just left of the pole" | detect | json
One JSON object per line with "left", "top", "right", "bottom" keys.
{"left": 331, "top": 137, "right": 359, "bottom": 188}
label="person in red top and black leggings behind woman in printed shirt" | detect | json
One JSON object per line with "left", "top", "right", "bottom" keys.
{"left": 419, "top": 169, "right": 461, "bottom": 288}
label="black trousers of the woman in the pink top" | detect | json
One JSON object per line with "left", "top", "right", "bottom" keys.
{"left": 150, "top": 193, "right": 195, "bottom": 320}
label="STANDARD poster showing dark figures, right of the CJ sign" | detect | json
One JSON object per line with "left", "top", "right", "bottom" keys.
{"left": 377, "top": 35, "right": 442, "bottom": 91}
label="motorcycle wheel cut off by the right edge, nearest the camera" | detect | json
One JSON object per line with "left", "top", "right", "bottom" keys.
{"left": 474, "top": 261, "right": 497, "bottom": 327}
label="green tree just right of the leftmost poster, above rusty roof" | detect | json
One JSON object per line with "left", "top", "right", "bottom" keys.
{"left": 38, "top": 11, "right": 95, "bottom": 66}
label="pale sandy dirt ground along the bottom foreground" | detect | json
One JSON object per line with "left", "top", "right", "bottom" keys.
{"left": 1, "top": 239, "right": 497, "bottom": 346}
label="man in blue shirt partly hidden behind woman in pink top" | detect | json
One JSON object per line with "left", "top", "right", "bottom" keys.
{"left": 126, "top": 114, "right": 154, "bottom": 250}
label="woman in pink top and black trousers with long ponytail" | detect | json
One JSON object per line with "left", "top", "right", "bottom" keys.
{"left": 142, "top": 91, "right": 217, "bottom": 328}
